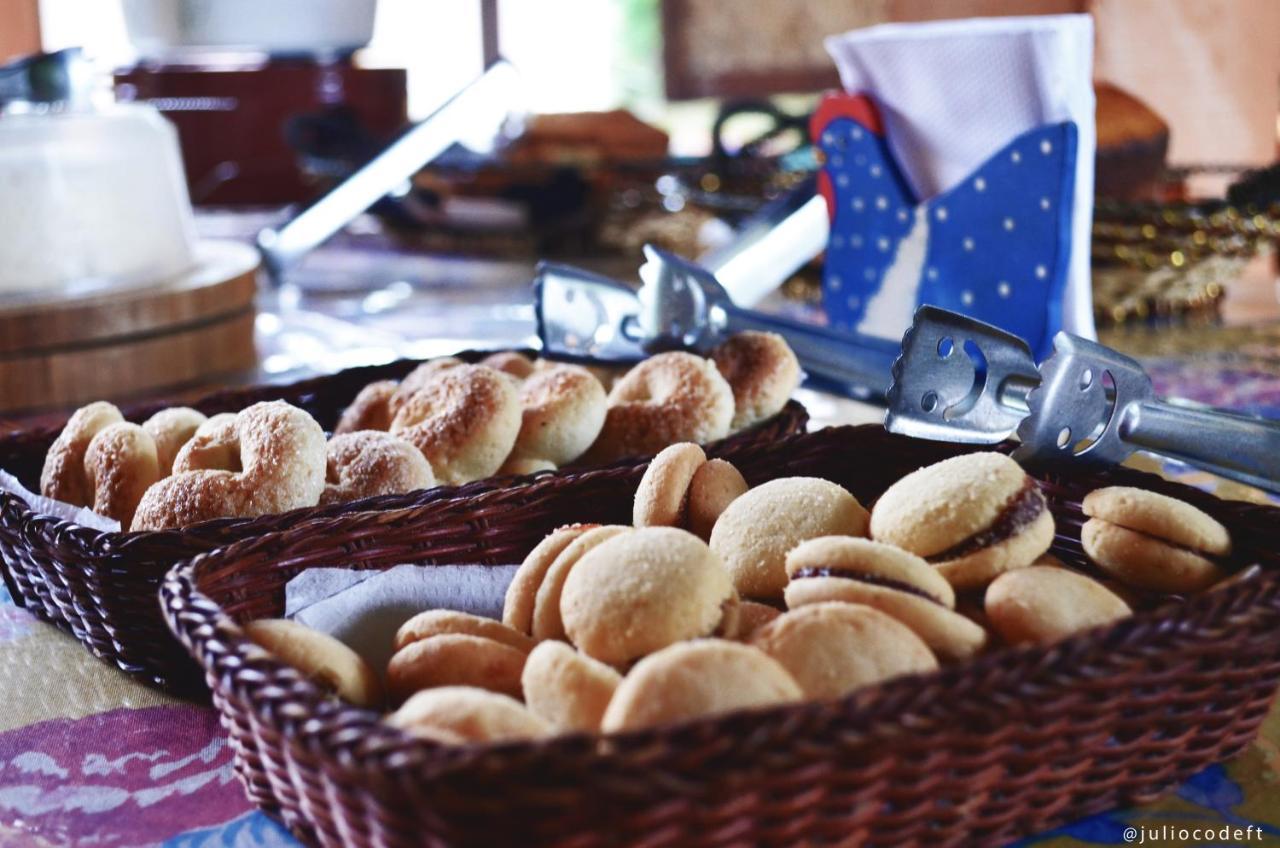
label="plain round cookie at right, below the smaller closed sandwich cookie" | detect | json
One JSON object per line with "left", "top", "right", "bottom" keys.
{"left": 983, "top": 565, "right": 1133, "bottom": 644}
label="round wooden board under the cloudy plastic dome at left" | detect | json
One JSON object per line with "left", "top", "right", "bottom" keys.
{"left": 0, "top": 242, "right": 257, "bottom": 412}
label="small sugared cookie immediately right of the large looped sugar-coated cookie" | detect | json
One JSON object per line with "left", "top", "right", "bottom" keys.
{"left": 320, "top": 430, "right": 435, "bottom": 506}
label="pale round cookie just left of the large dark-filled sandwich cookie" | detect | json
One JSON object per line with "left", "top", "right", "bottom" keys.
{"left": 710, "top": 477, "right": 867, "bottom": 599}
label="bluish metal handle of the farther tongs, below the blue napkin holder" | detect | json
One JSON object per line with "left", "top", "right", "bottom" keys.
{"left": 724, "top": 307, "right": 897, "bottom": 400}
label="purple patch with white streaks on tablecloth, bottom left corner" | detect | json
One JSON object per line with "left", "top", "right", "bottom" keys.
{"left": 0, "top": 706, "right": 251, "bottom": 845}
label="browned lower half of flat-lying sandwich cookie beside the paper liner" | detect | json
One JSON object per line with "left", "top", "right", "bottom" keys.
{"left": 387, "top": 633, "right": 529, "bottom": 703}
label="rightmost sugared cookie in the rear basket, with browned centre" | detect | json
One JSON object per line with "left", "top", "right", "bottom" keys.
{"left": 712, "top": 330, "right": 801, "bottom": 430}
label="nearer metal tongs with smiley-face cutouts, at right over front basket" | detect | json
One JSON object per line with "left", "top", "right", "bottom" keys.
{"left": 884, "top": 306, "right": 1280, "bottom": 492}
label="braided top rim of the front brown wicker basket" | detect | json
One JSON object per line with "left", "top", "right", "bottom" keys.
{"left": 160, "top": 424, "right": 1280, "bottom": 778}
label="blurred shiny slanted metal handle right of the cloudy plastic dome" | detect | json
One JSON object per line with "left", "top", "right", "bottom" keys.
{"left": 257, "top": 60, "right": 520, "bottom": 282}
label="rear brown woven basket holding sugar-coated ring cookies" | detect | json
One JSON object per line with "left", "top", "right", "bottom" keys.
{"left": 0, "top": 351, "right": 808, "bottom": 692}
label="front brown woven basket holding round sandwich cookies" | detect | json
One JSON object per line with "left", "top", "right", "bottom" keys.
{"left": 161, "top": 427, "right": 1280, "bottom": 848}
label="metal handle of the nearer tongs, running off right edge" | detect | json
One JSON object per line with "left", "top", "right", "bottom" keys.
{"left": 1120, "top": 401, "right": 1280, "bottom": 492}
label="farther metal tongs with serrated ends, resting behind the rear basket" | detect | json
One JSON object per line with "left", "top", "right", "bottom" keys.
{"left": 534, "top": 245, "right": 893, "bottom": 398}
